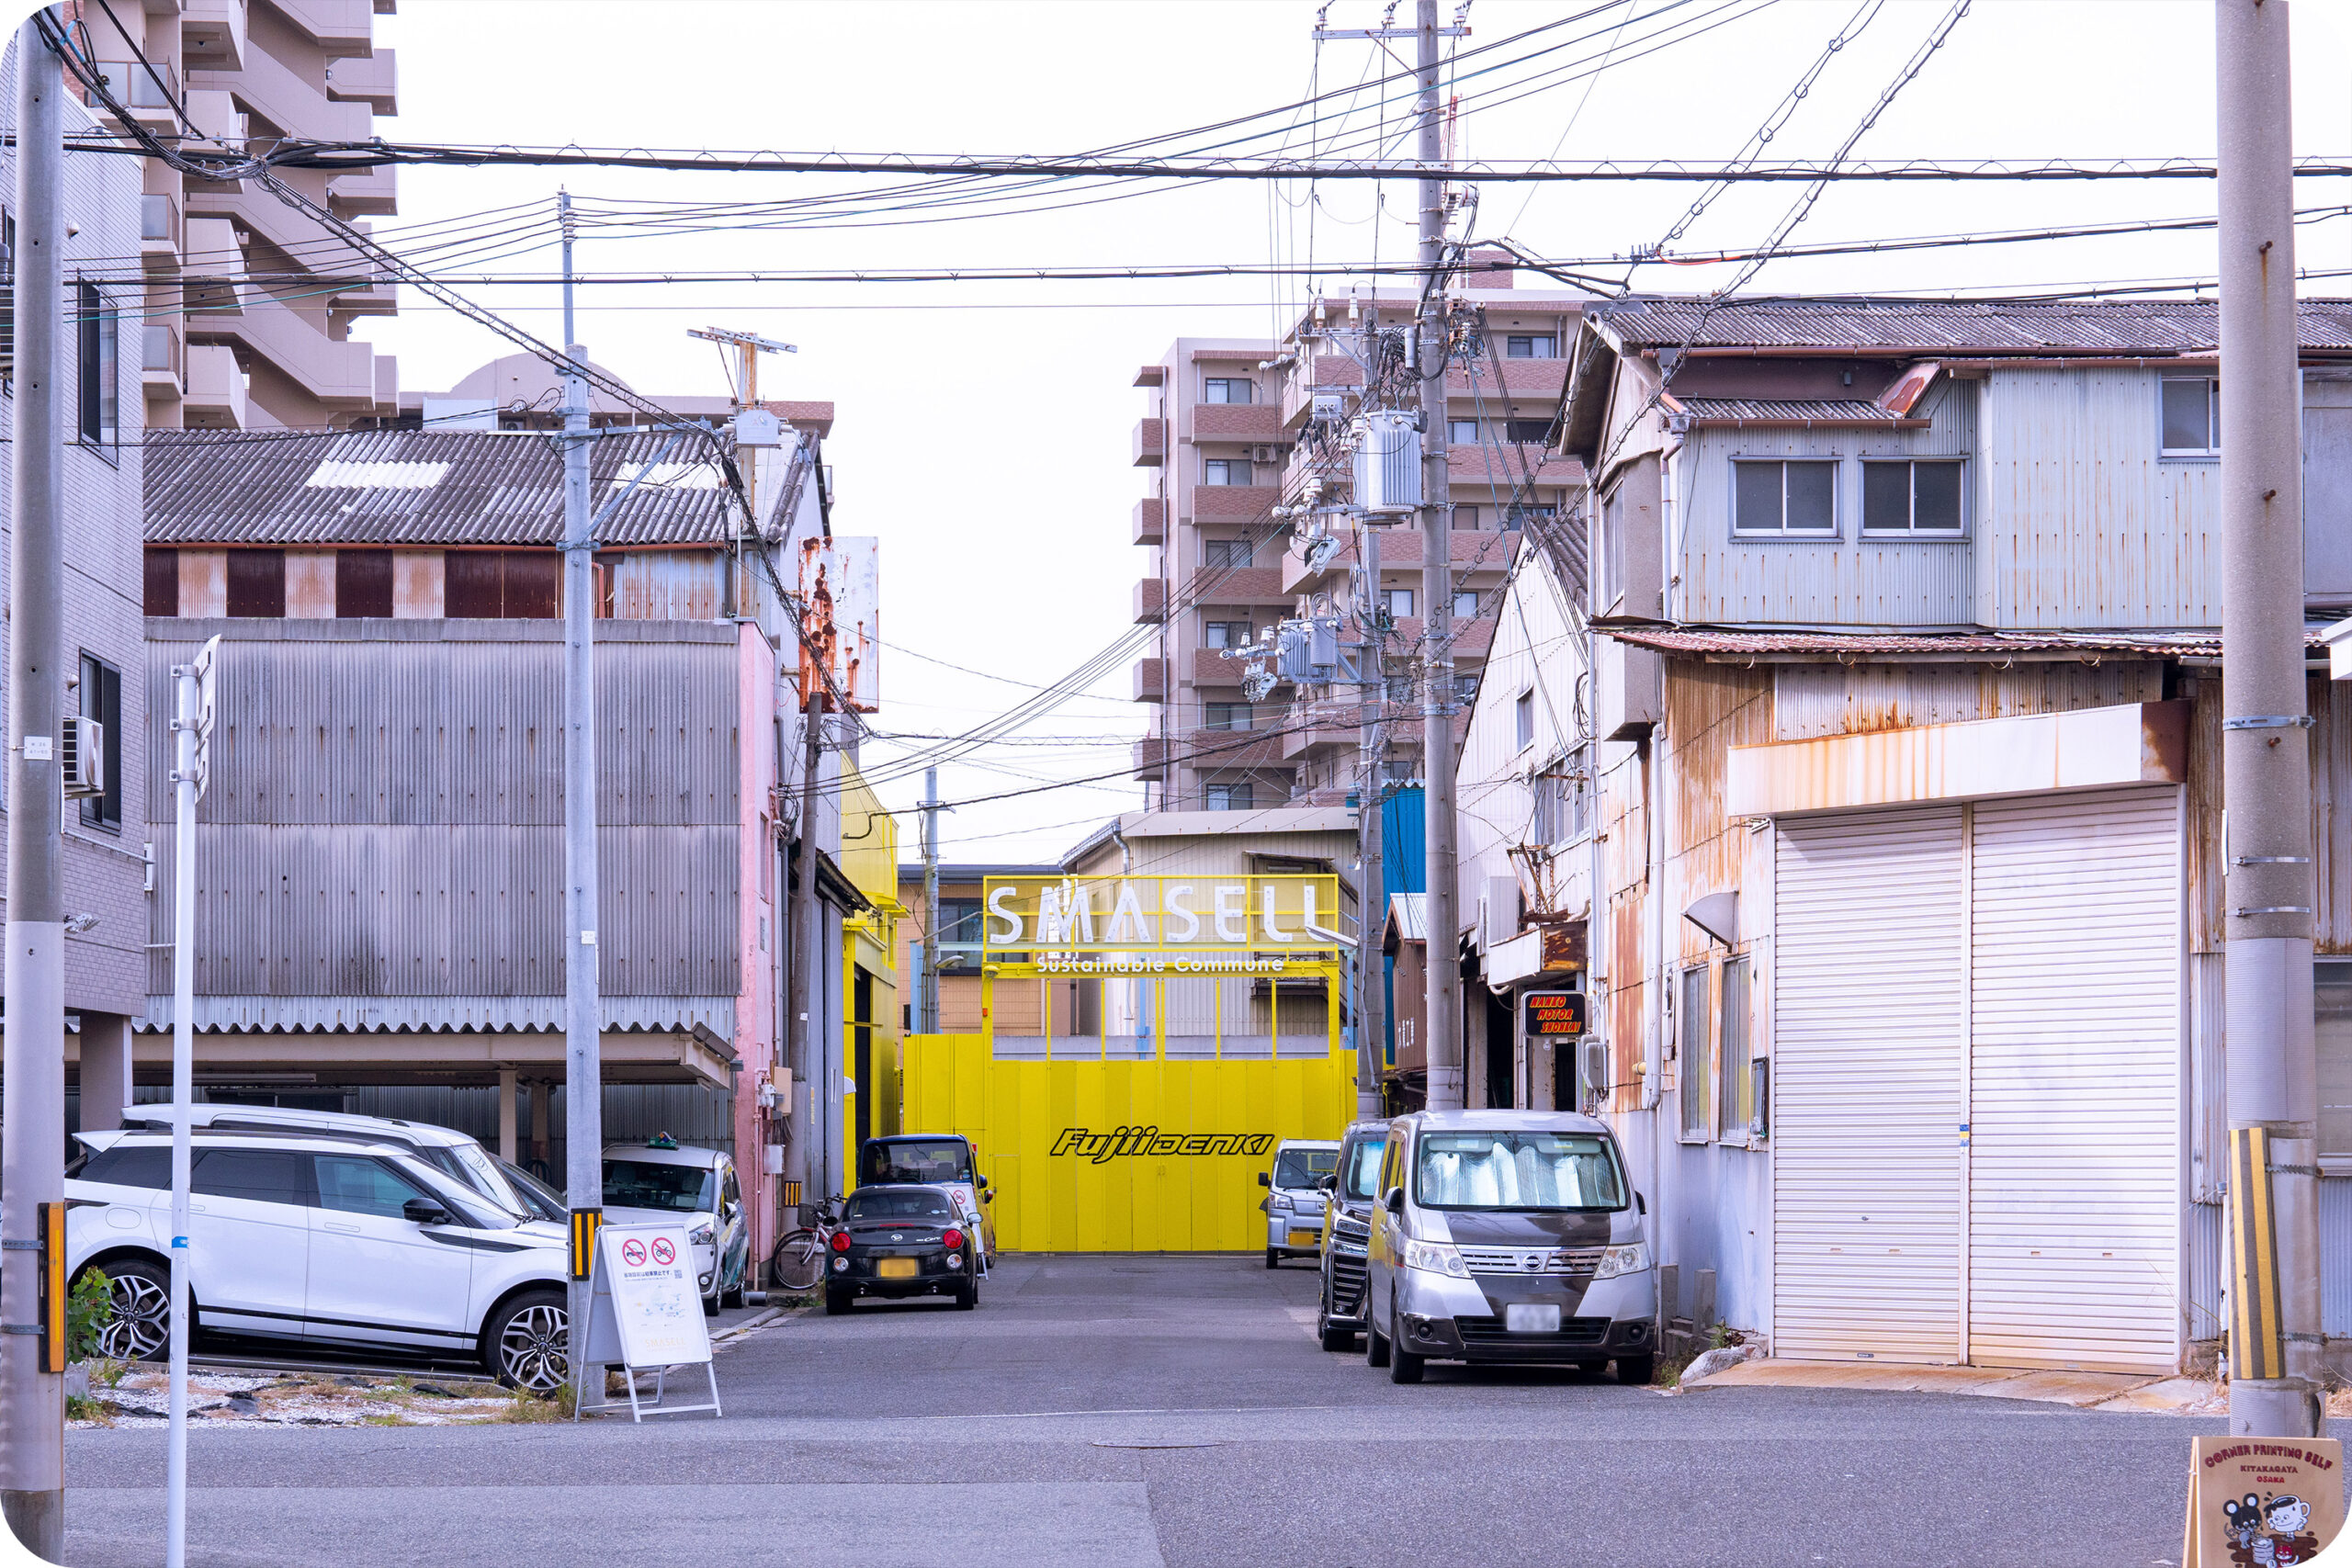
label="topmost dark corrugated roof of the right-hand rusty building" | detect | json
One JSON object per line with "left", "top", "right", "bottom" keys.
{"left": 1588, "top": 296, "right": 2352, "bottom": 355}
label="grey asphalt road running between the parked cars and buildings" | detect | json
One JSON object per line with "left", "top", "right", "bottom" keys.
{"left": 68, "top": 1256, "right": 2221, "bottom": 1568}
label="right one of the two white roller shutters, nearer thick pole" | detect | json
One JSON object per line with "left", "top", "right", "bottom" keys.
{"left": 1969, "top": 790, "right": 2183, "bottom": 1373}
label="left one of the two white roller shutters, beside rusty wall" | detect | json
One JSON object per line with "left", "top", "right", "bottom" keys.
{"left": 1771, "top": 807, "right": 1964, "bottom": 1361}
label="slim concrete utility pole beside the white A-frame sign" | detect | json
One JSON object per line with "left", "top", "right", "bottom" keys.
{"left": 555, "top": 193, "right": 605, "bottom": 1404}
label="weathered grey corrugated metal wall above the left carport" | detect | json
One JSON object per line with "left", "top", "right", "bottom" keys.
{"left": 148, "top": 621, "right": 741, "bottom": 997}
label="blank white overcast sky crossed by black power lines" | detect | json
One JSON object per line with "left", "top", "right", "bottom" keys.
{"left": 365, "top": 0, "right": 2352, "bottom": 861}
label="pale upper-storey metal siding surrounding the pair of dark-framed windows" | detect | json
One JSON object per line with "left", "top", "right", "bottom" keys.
{"left": 1675, "top": 381, "right": 1983, "bottom": 626}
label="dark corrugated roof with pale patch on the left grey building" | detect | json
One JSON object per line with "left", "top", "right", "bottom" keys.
{"left": 146, "top": 430, "right": 731, "bottom": 546}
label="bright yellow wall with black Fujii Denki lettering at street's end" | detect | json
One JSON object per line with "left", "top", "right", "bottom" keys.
{"left": 906, "top": 1034, "right": 1355, "bottom": 1253}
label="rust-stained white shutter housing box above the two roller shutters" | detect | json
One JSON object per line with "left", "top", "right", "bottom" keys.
{"left": 1743, "top": 660, "right": 2164, "bottom": 745}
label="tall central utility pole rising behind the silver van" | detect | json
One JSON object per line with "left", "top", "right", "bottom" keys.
{"left": 1414, "top": 0, "right": 1463, "bottom": 1110}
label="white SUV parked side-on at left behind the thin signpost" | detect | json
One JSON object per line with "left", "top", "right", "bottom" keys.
{"left": 66, "top": 1128, "right": 567, "bottom": 1392}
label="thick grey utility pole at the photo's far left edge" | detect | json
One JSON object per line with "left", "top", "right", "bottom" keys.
{"left": 0, "top": 14, "right": 66, "bottom": 1563}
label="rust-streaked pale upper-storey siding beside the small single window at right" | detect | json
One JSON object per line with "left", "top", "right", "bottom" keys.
{"left": 1966, "top": 369, "right": 2221, "bottom": 627}
